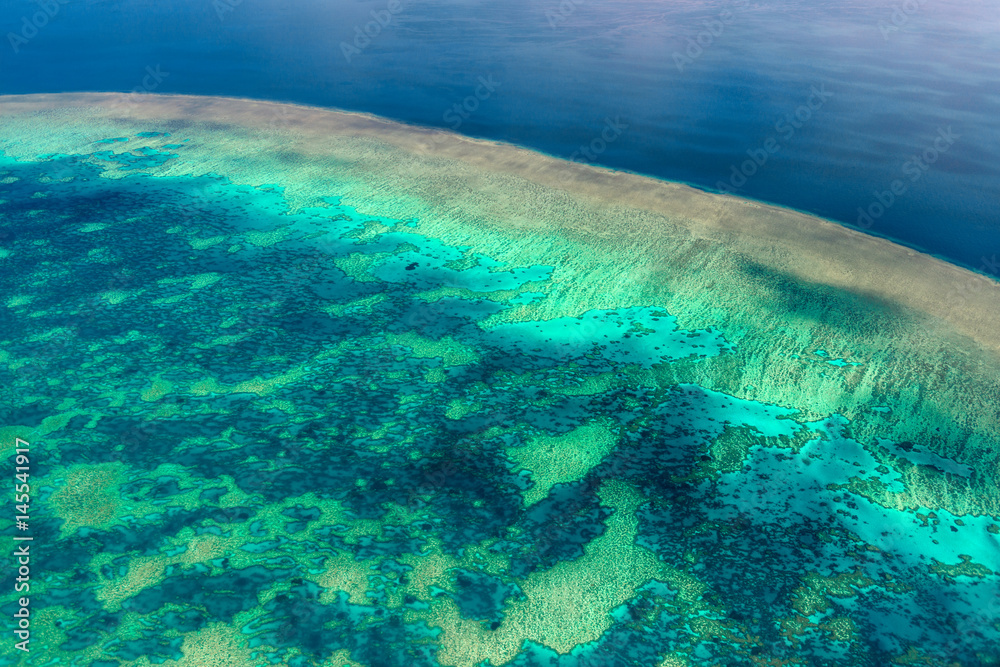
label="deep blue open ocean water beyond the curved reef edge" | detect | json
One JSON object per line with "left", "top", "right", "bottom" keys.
{"left": 0, "top": 0, "right": 1000, "bottom": 275}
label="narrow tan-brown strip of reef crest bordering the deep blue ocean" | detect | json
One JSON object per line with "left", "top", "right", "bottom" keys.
{"left": 0, "top": 93, "right": 1000, "bottom": 360}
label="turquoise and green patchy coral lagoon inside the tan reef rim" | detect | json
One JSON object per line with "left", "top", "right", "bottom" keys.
{"left": 0, "top": 98, "right": 1000, "bottom": 667}
